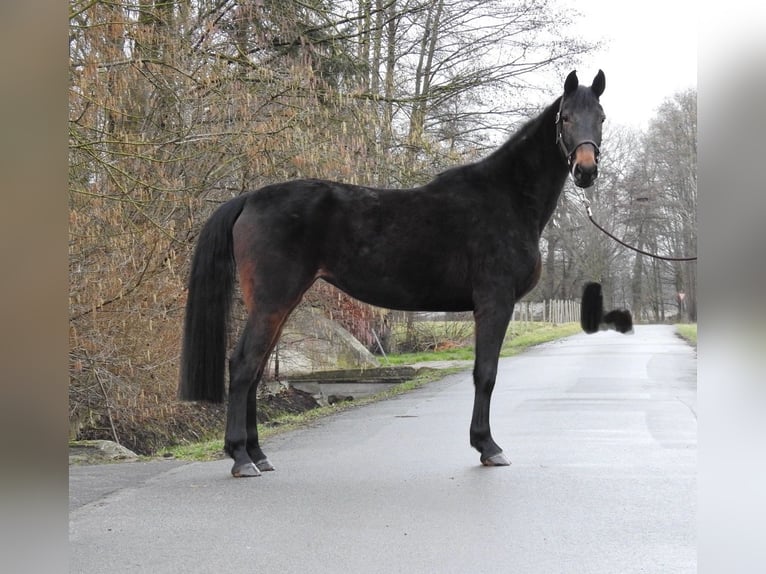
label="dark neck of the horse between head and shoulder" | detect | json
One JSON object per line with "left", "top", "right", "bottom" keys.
{"left": 482, "top": 101, "right": 567, "bottom": 232}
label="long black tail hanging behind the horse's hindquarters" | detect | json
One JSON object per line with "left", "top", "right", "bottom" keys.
{"left": 178, "top": 195, "right": 247, "bottom": 403}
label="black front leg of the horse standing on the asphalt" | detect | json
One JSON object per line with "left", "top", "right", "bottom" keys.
{"left": 470, "top": 302, "right": 513, "bottom": 466}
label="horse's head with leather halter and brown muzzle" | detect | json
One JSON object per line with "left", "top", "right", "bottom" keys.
{"left": 556, "top": 70, "right": 606, "bottom": 187}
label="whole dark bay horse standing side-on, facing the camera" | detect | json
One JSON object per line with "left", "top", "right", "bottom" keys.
{"left": 179, "top": 70, "right": 605, "bottom": 476}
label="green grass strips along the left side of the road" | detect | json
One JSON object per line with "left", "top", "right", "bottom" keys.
{"left": 163, "top": 323, "right": 584, "bottom": 461}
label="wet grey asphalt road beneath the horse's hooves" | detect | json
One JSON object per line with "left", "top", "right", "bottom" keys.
{"left": 69, "top": 326, "right": 697, "bottom": 574}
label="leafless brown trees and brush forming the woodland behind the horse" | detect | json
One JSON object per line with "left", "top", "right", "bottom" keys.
{"left": 69, "top": 0, "right": 697, "bottom": 454}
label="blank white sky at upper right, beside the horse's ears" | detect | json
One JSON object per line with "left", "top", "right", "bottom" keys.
{"left": 560, "top": 0, "right": 700, "bottom": 128}
